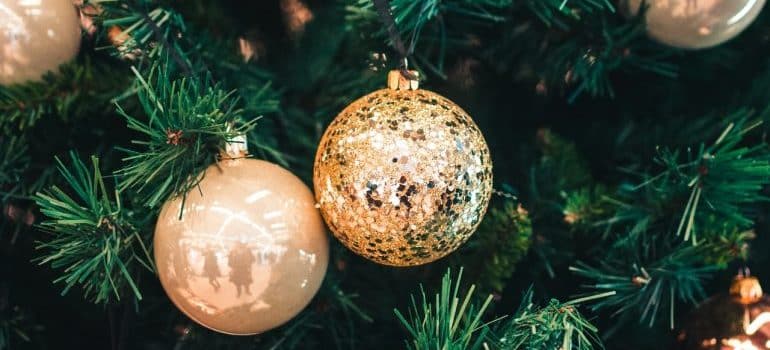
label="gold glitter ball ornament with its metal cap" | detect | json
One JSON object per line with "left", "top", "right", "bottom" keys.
{"left": 313, "top": 71, "right": 492, "bottom": 266}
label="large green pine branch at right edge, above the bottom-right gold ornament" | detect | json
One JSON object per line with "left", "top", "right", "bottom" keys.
{"left": 571, "top": 117, "right": 770, "bottom": 328}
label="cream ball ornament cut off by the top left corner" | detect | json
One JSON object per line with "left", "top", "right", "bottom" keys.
{"left": 0, "top": 0, "right": 80, "bottom": 85}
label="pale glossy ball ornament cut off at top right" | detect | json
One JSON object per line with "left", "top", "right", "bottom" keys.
{"left": 621, "top": 0, "right": 765, "bottom": 49}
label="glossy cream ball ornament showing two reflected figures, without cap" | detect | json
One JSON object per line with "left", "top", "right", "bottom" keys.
{"left": 155, "top": 159, "right": 329, "bottom": 335}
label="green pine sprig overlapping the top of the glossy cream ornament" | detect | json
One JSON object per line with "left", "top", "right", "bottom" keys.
{"left": 117, "top": 60, "right": 253, "bottom": 207}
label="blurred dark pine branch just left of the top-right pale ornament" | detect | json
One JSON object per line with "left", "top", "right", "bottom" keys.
{"left": 481, "top": 4, "right": 677, "bottom": 102}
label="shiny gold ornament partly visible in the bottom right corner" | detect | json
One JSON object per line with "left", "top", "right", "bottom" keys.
{"left": 679, "top": 275, "right": 770, "bottom": 350}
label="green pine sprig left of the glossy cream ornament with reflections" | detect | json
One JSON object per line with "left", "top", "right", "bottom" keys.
{"left": 35, "top": 153, "right": 153, "bottom": 303}
